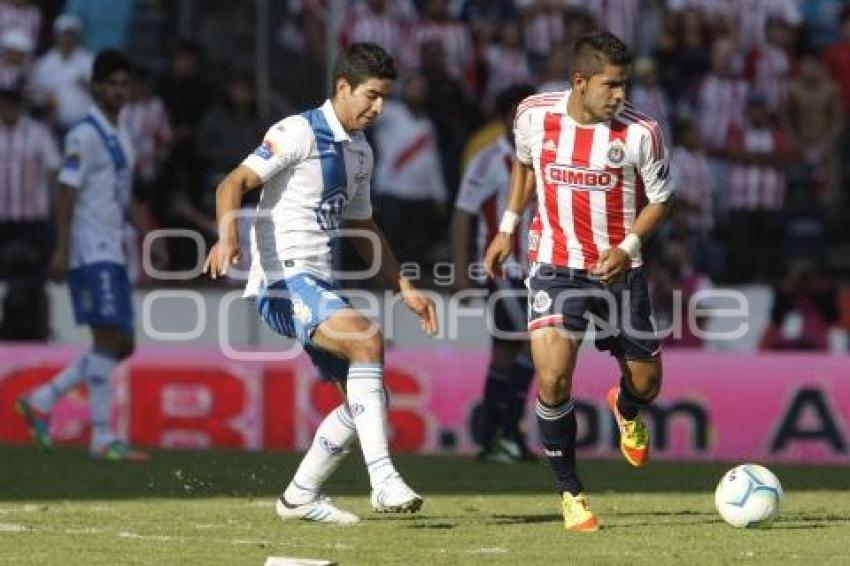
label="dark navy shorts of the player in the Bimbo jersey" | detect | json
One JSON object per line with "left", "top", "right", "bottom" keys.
{"left": 528, "top": 264, "right": 661, "bottom": 360}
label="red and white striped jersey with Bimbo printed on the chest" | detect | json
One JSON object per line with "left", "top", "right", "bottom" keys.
{"left": 514, "top": 90, "right": 674, "bottom": 269}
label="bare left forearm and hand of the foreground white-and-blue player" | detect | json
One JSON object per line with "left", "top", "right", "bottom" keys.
{"left": 204, "top": 165, "right": 263, "bottom": 279}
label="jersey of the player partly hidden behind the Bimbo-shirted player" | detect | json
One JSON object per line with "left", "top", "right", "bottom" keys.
{"left": 455, "top": 136, "right": 533, "bottom": 277}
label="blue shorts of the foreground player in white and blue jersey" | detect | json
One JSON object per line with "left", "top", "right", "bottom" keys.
{"left": 256, "top": 273, "right": 351, "bottom": 381}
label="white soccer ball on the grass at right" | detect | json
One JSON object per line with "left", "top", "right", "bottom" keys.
{"left": 714, "top": 464, "right": 784, "bottom": 529}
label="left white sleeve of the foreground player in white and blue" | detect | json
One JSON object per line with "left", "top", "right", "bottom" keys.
{"left": 242, "top": 116, "right": 314, "bottom": 183}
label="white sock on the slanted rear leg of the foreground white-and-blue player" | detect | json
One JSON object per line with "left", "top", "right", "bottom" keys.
{"left": 283, "top": 403, "right": 357, "bottom": 505}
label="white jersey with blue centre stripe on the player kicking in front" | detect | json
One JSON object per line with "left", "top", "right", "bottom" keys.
{"left": 238, "top": 101, "right": 373, "bottom": 297}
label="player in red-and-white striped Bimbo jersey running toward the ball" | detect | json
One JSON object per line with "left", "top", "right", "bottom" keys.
{"left": 485, "top": 32, "right": 673, "bottom": 532}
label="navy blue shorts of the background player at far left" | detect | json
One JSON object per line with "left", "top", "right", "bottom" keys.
{"left": 66, "top": 261, "right": 133, "bottom": 334}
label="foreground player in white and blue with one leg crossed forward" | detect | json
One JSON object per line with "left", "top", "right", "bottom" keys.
{"left": 204, "top": 43, "right": 437, "bottom": 523}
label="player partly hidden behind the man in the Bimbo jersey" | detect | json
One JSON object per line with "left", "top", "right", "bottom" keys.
{"left": 451, "top": 84, "right": 536, "bottom": 463}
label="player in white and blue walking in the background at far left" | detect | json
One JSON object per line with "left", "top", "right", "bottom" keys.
{"left": 16, "top": 50, "right": 158, "bottom": 460}
